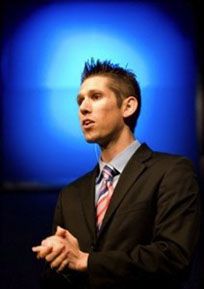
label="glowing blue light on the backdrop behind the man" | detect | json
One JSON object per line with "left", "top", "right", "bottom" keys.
{"left": 2, "top": 3, "right": 196, "bottom": 182}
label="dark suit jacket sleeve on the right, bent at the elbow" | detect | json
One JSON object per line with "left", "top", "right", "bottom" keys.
{"left": 88, "top": 158, "right": 200, "bottom": 288}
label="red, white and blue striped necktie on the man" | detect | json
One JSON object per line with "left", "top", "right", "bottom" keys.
{"left": 96, "top": 165, "right": 118, "bottom": 231}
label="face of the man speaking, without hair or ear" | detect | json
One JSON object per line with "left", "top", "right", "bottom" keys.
{"left": 77, "top": 76, "right": 125, "bottom": 145}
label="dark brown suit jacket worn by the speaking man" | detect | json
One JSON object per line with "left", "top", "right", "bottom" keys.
{"left": 40, "top": 144, "right": 200, "bottom": 289}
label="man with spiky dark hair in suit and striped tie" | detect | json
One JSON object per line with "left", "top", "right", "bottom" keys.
{"left": 33, "top": 60, "right": 199, "bottom": 289}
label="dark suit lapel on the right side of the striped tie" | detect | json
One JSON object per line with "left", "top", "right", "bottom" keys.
{"left": 99, "top": 144, "right": 152, "bottom": 236}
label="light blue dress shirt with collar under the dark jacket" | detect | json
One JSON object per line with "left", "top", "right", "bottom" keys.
{"left": 95, "top": 140, "right": 141, "bottom": 203}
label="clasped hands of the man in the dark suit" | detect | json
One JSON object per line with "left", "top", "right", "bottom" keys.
{"left": 32, "top": 226, "right": 89, "bottom": 272}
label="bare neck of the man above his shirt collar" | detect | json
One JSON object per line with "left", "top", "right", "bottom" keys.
{"left": 101, "top": 128, "right": 135, "bottom": 163}
